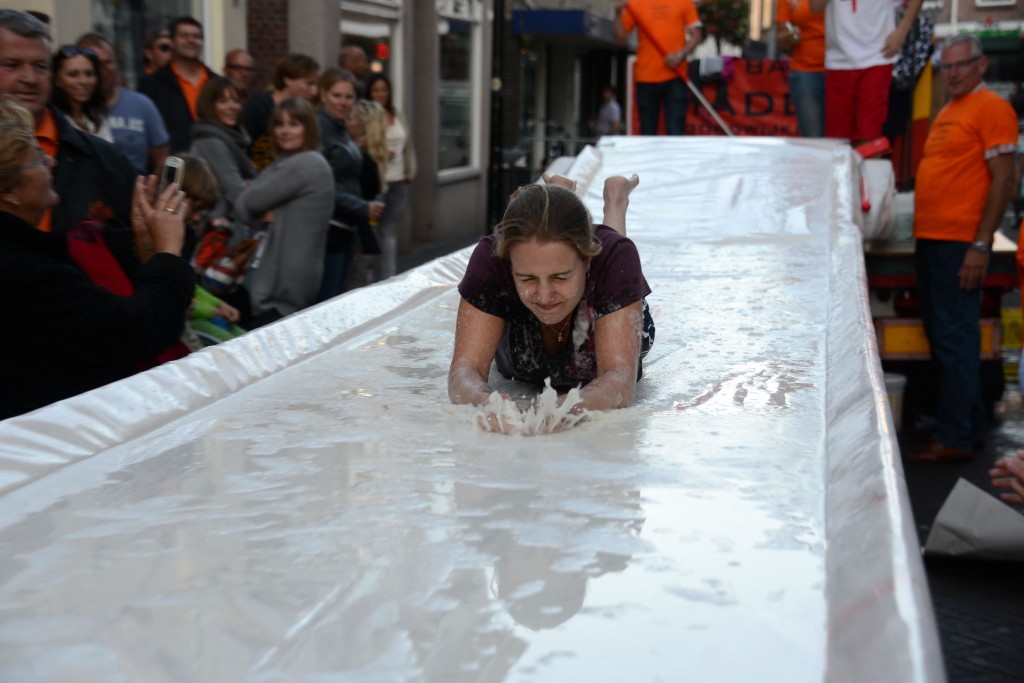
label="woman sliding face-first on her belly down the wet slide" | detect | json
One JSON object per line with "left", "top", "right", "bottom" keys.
{"left": 449, "top": 175, "right": 654, "bottom": 433}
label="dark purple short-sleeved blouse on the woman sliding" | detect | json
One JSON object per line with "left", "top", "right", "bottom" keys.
{"left": 459, "top": 225, "right": 650, "bottom": 389}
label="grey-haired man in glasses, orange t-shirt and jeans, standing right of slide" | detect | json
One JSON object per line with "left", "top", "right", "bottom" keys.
{"left": 907, "top": 35, "right": 1017, "bottom": 462}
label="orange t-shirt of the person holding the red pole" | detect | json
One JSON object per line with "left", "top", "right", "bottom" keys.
{"left": 620, "top": 0, "right": 700, "bottom": 83}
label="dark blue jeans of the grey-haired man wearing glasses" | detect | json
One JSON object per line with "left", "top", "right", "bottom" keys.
{"left": 913, "top": 240, "right": 985, "bottom": 451}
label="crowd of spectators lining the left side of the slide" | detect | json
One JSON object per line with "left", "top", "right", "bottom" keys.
{"left": 0, "top": 9, "right": 416, "bottom": 419}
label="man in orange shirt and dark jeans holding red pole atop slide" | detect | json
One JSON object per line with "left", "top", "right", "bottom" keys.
{"left": 613, "top": 0, "right": 702, "bottom": 135}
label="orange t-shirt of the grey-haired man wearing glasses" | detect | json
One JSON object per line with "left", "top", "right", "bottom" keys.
{"left": 913, "top": 87, "right": 1017, "bottom": 242}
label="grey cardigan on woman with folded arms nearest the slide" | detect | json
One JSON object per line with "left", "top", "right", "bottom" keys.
{"left": 234, "top": 152, "right": 334, "bottom": 315}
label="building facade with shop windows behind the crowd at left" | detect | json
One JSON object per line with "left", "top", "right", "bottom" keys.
{"left": 7, "top": 0, "right": 493, "bottom": 251}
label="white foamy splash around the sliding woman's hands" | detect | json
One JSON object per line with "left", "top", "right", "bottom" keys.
{"left": 473, "top": 377, "right": 587, "bottom": 436}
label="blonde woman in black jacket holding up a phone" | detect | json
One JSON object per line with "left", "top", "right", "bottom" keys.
{"left": 0, "top": 98, "right": 195, "bottom": 419}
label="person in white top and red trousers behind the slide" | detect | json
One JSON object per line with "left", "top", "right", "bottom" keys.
{"left": 810, "top": 0, "right": 923, "bottom": 145}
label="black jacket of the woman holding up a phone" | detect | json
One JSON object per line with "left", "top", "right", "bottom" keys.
{"left": 0, "top": 212, "right": 195, "bottom": 419}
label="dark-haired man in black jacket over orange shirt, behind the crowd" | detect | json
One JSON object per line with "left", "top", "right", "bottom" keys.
{"left": 138, "top": 16, "right": 215, "bottom": 154}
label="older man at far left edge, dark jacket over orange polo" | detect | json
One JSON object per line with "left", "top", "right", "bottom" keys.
{"left": 0, "top": 9, "right": 138, "bottom": 242}
